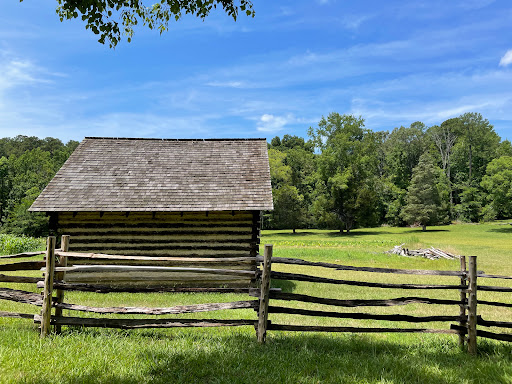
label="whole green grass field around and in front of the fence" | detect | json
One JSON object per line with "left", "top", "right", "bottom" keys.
{"left": 0, "top": 223, "right": 512, "bottom": 383}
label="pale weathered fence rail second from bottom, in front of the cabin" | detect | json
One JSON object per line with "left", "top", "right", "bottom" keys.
{"left": 54, "top": 300, "right": 259, "bottom": 315}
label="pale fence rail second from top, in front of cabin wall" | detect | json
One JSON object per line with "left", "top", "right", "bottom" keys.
{"left": 45, "top": 265, "right": 255, "bottom": 278}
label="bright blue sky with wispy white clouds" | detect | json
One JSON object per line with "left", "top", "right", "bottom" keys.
{"left": 0, "top": 0, "right": 512, "bottom": 141}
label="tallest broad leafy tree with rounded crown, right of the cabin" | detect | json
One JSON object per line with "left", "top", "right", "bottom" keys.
{"left": 309, "top": 112, "right": 378, "bottom": 233}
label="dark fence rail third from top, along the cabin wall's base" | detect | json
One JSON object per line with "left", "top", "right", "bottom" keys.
{"left": 37, "top": 281, "right": 250, "bottom": 293}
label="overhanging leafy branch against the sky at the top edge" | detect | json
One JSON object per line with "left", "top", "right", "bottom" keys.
{"left": 39, "top": 0, "right": 254, "bottom": 48}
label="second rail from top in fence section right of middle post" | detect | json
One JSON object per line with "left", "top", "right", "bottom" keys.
{"left": 271, "top": 271, "right": 466, "bottom": 289}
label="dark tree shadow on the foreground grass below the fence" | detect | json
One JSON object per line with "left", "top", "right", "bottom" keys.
{"left": 139, "top": 335, "right": 512, "bottom": 384}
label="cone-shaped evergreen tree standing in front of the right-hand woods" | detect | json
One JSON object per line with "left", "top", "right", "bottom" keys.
{"left": 401, "top": 153, "right": 441, "bottom": 231}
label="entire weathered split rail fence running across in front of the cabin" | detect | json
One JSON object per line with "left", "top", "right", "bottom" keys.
{"left": 0, "top": 236, "right": 512, "bottom": 354}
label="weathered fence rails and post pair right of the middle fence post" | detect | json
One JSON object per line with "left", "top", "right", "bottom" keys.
{"left": 258, "top": 256, "right": 512, "bottom": 354}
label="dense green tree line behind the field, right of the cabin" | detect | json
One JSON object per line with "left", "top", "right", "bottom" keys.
{"left": 264, "top": 112, "right": 512, "bottom": 232}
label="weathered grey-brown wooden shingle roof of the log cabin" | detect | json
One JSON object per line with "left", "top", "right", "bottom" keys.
{"left": 30, "top": 137, "right": 273, "bottom": 212}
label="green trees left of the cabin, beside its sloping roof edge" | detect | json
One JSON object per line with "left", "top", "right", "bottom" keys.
{"left": 0, "top": 135, "right": 78, "bottom": 236}
